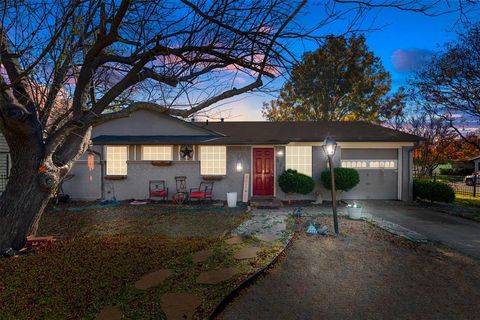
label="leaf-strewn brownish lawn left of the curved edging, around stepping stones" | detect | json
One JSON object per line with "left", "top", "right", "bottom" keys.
{"left": 0, "top": 206, "right": 283, "bottom": 320}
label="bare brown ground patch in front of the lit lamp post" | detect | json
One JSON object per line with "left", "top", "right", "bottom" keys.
{"left": 220, "top": 217, "right": 480, "bottom": 320}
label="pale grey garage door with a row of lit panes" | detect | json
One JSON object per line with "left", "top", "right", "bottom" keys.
{"left": 342, "top": 149, "right": 398, "bottom": 199}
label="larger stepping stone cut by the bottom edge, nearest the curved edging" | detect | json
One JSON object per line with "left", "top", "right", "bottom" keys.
{"left": 160, "top": 293, "right": 202, "bottom": 320}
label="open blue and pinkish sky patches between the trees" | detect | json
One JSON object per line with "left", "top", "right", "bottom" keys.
{"left": 215, "top": 2, "right": 480, "bottom": 121}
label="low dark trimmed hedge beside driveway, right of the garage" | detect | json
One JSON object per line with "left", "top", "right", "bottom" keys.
{"left": 413, "top": 179, "right": 455, "bottom": 203}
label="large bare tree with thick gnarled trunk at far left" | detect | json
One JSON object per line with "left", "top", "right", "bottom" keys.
{"left": 0, "top": 0, "right": 474, "bottom": 252}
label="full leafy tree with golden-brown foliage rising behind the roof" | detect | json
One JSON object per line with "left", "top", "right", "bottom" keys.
{"left": 263, "top": 36, "right": 403, "bottom": 122}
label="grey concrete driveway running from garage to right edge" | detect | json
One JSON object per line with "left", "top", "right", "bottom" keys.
{"left": 358, "top": 200, "right": 480, "bottom": 259}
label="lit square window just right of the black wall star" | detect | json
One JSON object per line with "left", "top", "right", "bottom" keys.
{"left": 200, "top": 146, "right": 227, "bottom": 175}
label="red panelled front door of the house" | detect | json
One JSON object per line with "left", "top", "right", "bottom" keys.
{"left": 253, "top": 148, "right": 275, "bottom": 196}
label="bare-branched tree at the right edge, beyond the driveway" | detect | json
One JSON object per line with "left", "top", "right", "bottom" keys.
{"left": 412, "top": 24, "right": 480, "bottom": 150}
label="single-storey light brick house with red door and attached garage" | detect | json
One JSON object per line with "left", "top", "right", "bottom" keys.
{"left": 58, "top": 110, "right": 420, "bottom": 201}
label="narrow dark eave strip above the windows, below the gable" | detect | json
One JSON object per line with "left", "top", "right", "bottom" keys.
{"left": 92, "top": 135, "right": 218, "bottom": 145}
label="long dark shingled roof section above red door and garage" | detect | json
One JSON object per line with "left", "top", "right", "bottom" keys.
{"left": 191, "top": 121, "right": 423, "bottom": 145}
